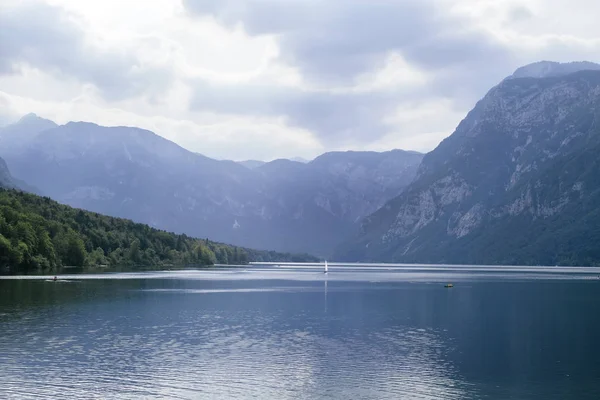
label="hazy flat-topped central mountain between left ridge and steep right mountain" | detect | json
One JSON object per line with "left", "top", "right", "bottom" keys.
{"left": 256, "top": 150, "right": 423, "bottom": 256}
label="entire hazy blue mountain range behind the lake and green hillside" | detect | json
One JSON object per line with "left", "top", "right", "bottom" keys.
{"left": 5, "top": 62, "right": 600, "bottom": 265}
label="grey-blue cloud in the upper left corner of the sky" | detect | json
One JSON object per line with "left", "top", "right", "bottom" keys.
{"left": 0, "top": 1, "right": 168, "bottom": 99}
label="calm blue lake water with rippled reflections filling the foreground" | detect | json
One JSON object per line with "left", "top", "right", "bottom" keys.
{"left": 0, "top": 267, "right": 600, "bottom": 400}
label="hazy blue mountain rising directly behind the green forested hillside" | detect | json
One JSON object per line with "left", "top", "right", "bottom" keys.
{"left": 0, "top": 122, "right": 262, "bottom": 247}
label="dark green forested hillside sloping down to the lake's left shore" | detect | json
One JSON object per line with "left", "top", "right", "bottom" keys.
{"left": 0, "top": 189, "right": 316, "bottom": 272}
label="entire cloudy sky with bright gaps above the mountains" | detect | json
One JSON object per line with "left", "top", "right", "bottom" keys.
{"left": 0, "top": 0, "right": 600, "bottom": 160}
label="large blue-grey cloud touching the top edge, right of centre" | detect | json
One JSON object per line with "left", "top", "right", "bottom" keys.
{"left": 184, "top": 0, "right": 510, "bottom": 84}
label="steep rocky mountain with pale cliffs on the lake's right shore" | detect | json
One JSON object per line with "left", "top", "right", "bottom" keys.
{"left": 336, "top": 63, "right": 600, "bottom": 265}
